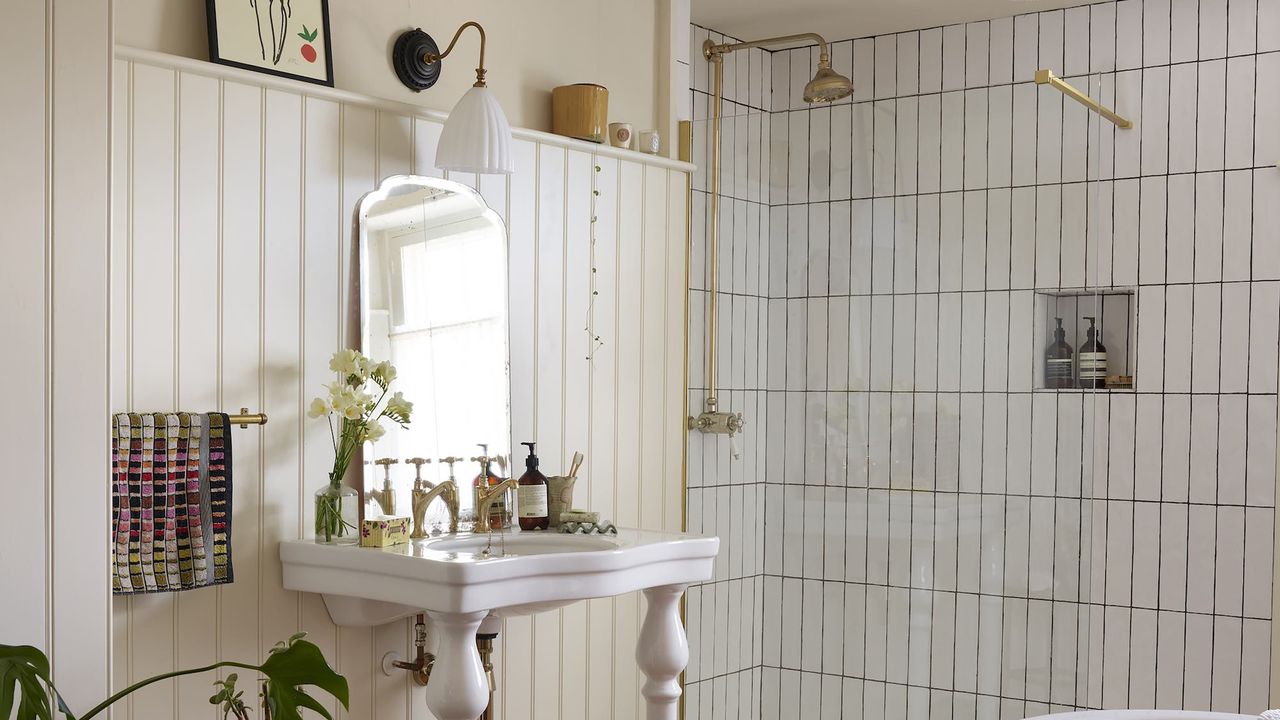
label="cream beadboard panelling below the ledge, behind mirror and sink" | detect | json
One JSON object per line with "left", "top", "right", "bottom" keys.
{"left": 116, "top": 51, "right": 687, "bottom": 719}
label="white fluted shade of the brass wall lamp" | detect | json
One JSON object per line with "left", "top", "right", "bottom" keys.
{"left": 435, "top": 87, "right": 516, "bottom": 174}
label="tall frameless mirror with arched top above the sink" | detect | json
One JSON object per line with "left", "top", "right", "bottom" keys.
{"left": 358, "top": 176, "right": 511, "bottom": 527}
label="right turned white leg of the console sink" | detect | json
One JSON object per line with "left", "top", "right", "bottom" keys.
{"left": 636, "top": 585, "right": 689, "bottom": 720}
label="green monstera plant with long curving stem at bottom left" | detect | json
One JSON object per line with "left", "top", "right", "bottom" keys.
{"left": 0, "top": 633, "right": 349, "bottom": 720}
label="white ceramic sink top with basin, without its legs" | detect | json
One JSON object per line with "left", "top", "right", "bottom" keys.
{"left": 280, "top": 528, "right": 719, "bottom": 625}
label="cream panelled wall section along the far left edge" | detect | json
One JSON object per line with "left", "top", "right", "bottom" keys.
{"left": 0, "top": 0, "right": 113, "bottom": 707}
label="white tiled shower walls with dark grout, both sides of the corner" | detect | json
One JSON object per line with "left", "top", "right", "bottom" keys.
{"left": 689, "top": 0, "right": 1280, "bottom": 720}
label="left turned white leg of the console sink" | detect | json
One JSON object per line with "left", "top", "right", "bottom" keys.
{"left": 426, "top": 610, "right": 489, "bottom": 720}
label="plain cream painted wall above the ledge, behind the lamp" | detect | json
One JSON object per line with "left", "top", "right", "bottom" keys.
{"left": 115, "top": 0, "right": 665, "bottom": 131}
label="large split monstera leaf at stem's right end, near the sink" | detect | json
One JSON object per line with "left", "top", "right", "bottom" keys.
{"left": 261, "top": 635, "right": 349, "bottom": 720}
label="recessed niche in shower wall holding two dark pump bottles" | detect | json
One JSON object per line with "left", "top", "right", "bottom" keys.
{"left": 1032, "top": 287, "right": 1138, "bottom": 392}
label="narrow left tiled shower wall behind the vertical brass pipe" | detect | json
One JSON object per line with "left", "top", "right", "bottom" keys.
{"left": 685, "top": 26, "right": 773, "bottom": 717}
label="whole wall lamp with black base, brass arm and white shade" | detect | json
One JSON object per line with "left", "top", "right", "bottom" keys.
{"left": 392, "top": 20, "right": 516, "bottom": 174}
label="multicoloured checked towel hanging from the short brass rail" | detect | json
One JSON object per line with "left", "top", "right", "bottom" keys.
{"left": 111, "top": 413, "right": 233, "bottom": 594}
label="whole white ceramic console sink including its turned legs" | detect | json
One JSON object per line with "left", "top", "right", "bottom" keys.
{"left": 280, "top": 529, "right": 719, "bottom": 720}
